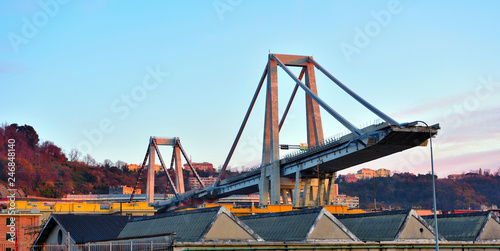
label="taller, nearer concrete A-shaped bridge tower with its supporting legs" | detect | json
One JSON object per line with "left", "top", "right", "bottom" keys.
{"left": 259, "top": 54, "right": 348, "bottom": 207}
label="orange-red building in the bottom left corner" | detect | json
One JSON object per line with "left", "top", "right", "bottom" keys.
{"left": 0, "top": 213, "right": 42, "bottom": 251}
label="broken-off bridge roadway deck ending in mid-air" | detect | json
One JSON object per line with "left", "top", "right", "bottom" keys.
{"left": 155, "top": 122, "right": 439, "bottom": 207}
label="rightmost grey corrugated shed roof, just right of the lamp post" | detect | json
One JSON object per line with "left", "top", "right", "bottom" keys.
{"left": 422, "top": 212, "right": 490, "bottom": 241}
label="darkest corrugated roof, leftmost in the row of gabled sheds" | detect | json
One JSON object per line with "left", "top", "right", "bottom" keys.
{"left": 53, "top": 214, "right": 129, "bottom": 243}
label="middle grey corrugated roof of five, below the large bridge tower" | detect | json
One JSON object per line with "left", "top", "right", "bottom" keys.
{"left": 239, "top": 208, "right": 321, "bottom": 241}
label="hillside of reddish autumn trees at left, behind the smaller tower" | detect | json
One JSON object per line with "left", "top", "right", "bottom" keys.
{"left": 0, "top": 124, "right": 237, "bottom": 198}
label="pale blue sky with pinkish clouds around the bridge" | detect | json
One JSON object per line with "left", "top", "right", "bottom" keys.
{"left": 0, "top": 0, "right": 500, "bottom": 177}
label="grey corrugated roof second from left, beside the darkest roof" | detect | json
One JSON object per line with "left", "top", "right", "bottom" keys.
{"left": 118, "top": 207, "right": 221, "bottom": 242}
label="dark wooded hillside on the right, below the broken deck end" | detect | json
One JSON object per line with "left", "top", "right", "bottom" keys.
{"left": 337, "top": 172, "right": 500, "bottom": 210}
